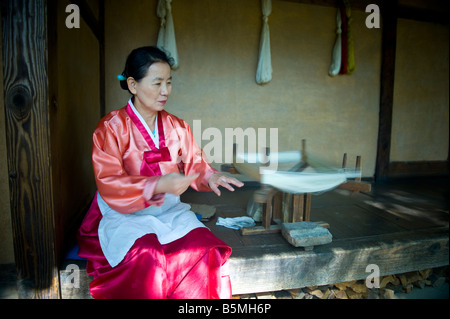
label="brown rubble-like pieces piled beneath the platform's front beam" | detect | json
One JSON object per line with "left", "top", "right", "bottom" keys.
{"left": 233, "top": 267, "right": 448, "bottom": 299}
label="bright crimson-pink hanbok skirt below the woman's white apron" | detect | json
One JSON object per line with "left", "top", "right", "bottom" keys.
{"left": 77, "top": 196, "right": 231, "bottom": 299}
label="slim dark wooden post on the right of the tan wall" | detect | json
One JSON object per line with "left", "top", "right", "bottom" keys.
{"left": 375, "top": 0, "right": 397, "bottom": 181}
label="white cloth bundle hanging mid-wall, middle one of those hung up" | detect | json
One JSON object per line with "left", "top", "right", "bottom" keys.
{"left": 256, "top": 0, "right": 272, "bottom": 84}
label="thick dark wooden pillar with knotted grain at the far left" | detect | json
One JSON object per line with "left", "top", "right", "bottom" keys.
{"left": 2, "top": 0, "right": 60, "bottom": 298}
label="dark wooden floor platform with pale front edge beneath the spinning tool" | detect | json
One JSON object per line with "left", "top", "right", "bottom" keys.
{"left": 61, "top": 178, "right": 449, "bottom": 298}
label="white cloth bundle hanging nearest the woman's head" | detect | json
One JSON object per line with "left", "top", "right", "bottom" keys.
{"left": 156, "top": 0, "right": 179, "bottom": 69}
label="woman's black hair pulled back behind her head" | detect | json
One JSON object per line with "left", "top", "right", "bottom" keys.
{"left": 120, "top": 46, "right": 174, "bottom": 93}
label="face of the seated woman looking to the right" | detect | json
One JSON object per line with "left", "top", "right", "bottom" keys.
{"left": 127, "top": 62, "right": 172, "bottom": 112}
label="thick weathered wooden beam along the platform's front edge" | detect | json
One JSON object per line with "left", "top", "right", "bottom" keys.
{"left": 229, "top": 227, "right": 449, "bottom": 294}
